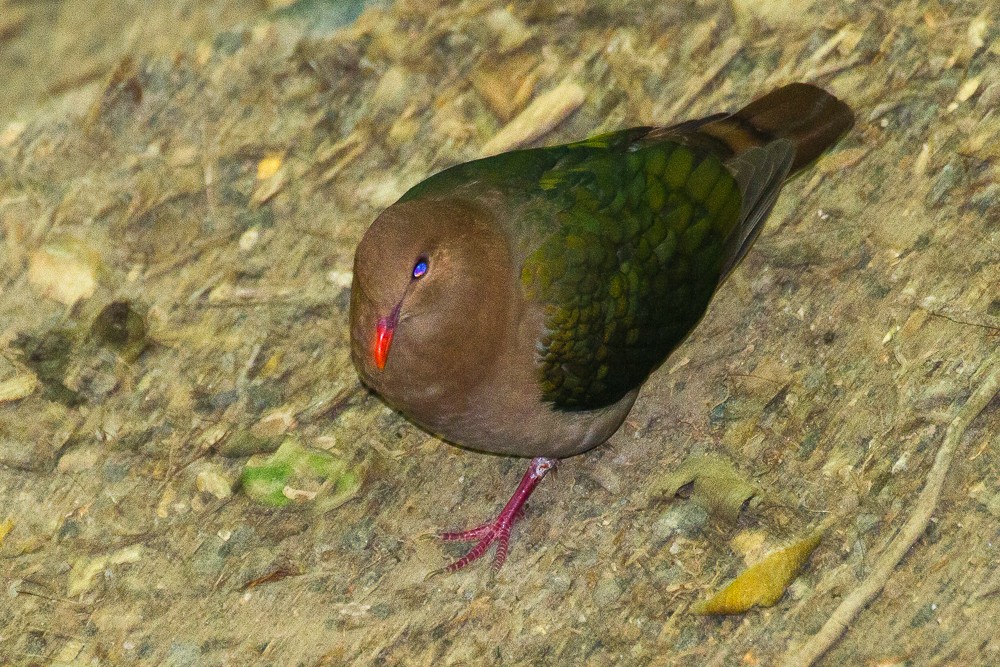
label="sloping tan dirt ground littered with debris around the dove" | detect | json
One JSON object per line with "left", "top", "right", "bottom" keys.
{"left": 0, "top": 0, "right": 1000, "bottom": 666}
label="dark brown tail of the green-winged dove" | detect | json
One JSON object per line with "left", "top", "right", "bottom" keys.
{"left": 699, "top": 83, "right": 854, "bottom": 174}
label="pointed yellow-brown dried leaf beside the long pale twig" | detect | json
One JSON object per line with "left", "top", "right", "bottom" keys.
{"left": 691, "top": 529, "right": 823, "bottom": 616}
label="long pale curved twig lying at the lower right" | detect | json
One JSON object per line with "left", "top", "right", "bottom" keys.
{"left": 781, "top": 356, "right": 1000, "bottom": 667}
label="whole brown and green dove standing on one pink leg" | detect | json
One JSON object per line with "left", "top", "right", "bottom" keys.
{"left": 351, "top": 83, "right": 853, "bottom": 571}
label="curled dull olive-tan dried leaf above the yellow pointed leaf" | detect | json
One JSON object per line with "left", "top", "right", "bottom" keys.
{"left": 656, "top": 456, "right": 760, "bottom": 523}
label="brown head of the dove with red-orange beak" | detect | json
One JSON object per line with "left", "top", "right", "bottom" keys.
{"left": 351, "top": 199, "right": 515, "bottom": 437}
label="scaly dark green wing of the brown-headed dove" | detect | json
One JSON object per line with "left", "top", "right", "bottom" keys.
{"left": 521, "top": 128, "right": 741, "bottom": 410}
